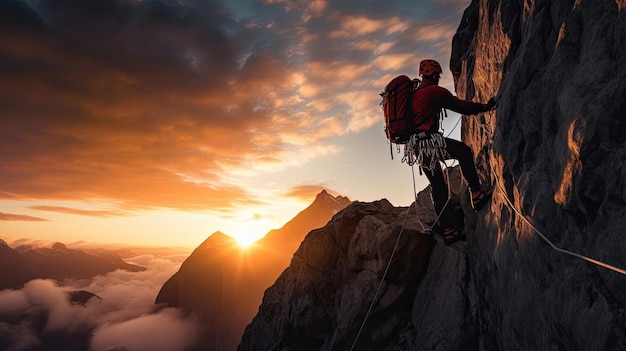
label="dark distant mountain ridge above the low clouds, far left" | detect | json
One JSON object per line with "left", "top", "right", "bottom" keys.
{"left": 0, "top": 241, "right": 146, "bottom": 290}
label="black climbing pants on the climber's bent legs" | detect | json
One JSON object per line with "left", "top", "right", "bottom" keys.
{"left": 423, "top": 138, "right": 480, "bottom": 229}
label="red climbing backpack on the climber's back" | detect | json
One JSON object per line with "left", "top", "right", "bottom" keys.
{"left": 380, "top": 75, "right": 419, "bottom": 144}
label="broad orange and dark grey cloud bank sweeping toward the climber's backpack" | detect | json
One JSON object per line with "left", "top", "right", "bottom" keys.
{"left": 0, "top": 0, "right": 466, "bottom": 216}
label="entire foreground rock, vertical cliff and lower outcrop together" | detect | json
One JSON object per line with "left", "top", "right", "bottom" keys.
{"left": 239, "top": 0, "right": 626, "bottom": 350}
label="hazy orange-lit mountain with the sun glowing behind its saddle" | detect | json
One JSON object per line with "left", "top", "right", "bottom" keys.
{"left": 155, "top": 190, "right": 352, "bottom": 351}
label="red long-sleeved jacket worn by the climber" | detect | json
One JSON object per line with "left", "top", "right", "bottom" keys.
{"left": 413, "top": 79, "right": 488, "bottom": 133}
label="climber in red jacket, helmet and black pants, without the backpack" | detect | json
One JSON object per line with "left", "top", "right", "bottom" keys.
{"left": 413, "top": 60, "right": 496, "bottom": 245}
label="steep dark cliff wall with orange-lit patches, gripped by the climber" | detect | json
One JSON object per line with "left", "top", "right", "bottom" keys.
{"left": 451, "top": 0, "right": 626, "bottom": 350}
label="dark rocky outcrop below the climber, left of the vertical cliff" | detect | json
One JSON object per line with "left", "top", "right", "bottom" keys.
{"left": 239, "top": 174, "right": 477, "bottom": 351}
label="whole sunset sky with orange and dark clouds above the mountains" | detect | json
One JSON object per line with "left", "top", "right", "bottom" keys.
{"left": 0, "top": 0, "right": 470, "bottom": 248}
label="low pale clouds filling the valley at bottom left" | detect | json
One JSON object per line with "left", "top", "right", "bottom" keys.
{"left": 0, "top": 255, "right": 199, "bottom": 351}
